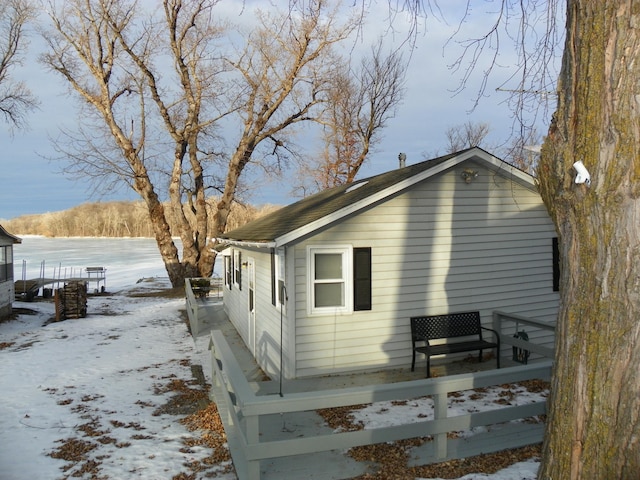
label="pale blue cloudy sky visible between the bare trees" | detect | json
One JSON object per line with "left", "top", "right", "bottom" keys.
{"left": 0, "top": 0, "right": 550, "bottom": 220}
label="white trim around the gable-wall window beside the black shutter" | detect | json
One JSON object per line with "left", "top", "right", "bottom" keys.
{"left": 307, "top": 245, "right": 353, "bottom": 315}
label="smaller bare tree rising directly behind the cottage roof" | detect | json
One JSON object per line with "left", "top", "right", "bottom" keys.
{"left": 298, "top": 39, "right": 407, "bottom": 194}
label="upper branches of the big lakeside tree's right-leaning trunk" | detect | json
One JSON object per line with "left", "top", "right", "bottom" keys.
{"left": 216, "top": 1, "right": 358, "bottom": 216}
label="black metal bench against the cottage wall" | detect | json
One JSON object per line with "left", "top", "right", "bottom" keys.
{"left": 411, "top": 312, "right": 500, "bottom": 378}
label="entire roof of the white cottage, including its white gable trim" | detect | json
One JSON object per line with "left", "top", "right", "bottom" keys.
{"left": 219, "top": 147, "right": 534, "bottom": 246}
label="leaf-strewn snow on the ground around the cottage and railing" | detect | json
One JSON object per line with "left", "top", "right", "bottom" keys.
{"left": 0, "top": 280, "right": 538, "bottom": 480}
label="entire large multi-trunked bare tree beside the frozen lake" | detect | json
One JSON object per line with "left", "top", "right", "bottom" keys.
{"left": 43, "top": 0, "right": 356, "bottom": 286}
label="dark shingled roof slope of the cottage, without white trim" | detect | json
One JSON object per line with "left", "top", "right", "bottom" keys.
{"left": 220, "top": 149, "right": 471, "bottom": 242}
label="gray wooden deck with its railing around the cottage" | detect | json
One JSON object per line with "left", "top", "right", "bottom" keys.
{"left": 187, "top": 299, "right": 551, "bottom": 480}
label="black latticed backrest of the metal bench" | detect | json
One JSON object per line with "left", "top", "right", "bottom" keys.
{"left": 411, "top": 311, "right": 482, "bottom": 341}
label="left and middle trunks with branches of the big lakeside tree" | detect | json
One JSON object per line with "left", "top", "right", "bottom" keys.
{"left": 43, "top": 0, "right": 222, "bottom": 285}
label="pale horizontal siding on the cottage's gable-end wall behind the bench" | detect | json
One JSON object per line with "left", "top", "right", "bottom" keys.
{"left": 290, "top": 163, "right": 559, "bottom": 377}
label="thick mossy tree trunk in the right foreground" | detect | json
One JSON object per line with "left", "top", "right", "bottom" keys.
{"left": 538, "top": 0, "right": 640, "bottom": 480}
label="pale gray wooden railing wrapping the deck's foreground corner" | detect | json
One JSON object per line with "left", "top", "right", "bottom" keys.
{"left": 210, "top": 331, "right": 551, "bottom": 480}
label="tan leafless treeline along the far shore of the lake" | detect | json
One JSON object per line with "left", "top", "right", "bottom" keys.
{"left": 2, "top": 202, "right": 280, "bottom": 237}
